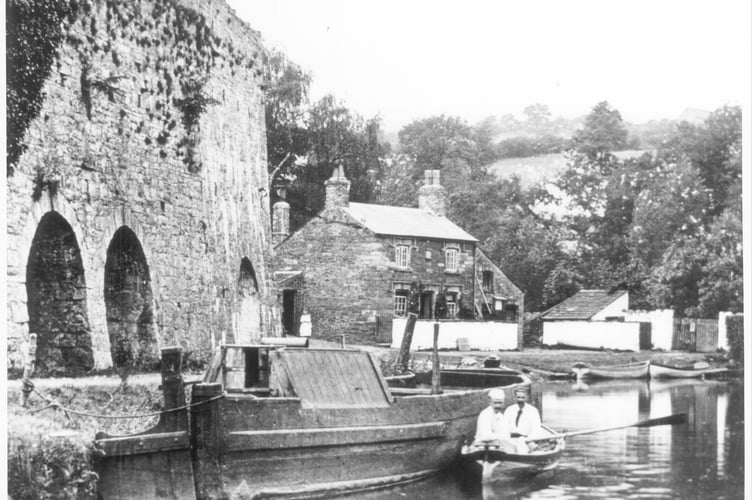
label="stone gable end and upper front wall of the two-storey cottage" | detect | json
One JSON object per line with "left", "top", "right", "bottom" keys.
{"left": 275, "top": 207, "right": 482, "bottom": 343}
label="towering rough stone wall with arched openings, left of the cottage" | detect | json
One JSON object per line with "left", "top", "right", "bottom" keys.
{"left": 7, "top": 0, "right": 279, "bottom": 373}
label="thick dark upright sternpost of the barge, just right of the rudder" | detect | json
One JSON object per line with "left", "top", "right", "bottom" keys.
{"left": 191, "top": 383, "right": 226, "bottom": 498}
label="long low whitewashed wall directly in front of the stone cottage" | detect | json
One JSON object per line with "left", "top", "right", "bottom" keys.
{"left": 392, "top": 318, "right": 517, "bottom": 351}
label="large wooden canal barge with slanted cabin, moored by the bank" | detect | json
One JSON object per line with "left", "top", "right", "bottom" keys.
{"left": 95, "top": 345, "right": 530, "bottom": 499}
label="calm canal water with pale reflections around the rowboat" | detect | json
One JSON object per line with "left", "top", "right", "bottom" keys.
{"left": 356, "top": 380, "right": 746, "bottom": 500}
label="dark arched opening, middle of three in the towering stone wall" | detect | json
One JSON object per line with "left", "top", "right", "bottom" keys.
{"left": 104, "top": 226, "right": 159, "bottom": 376}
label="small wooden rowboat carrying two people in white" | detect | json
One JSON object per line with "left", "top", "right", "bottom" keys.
{"left": 462, "top": 425, "right": 566, "bottom": 483}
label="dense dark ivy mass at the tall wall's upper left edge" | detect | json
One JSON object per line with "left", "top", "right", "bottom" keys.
{"left": 5, "top": 0, "right": 78, "bottom": 176}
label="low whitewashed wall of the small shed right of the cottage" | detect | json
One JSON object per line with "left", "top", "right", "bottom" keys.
{"left": 542, "top": 321, "right": 640, "bottom": 351}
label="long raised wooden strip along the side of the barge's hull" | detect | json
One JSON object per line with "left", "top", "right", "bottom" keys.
{"left": 226, "top": 422, "right": 447, "bottom": 452}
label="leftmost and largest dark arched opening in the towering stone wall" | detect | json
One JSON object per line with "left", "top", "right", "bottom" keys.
{"left": 26, "top": 212, "right": 94, "bottom": 376}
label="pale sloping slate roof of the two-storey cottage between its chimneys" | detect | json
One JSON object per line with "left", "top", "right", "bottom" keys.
{"left": 342, "top": 202, "right": 478, "bottom": 242}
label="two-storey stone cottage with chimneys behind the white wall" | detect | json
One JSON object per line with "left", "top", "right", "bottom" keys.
{"left": 272, "top": 166, "right": 524, "bottom": 343}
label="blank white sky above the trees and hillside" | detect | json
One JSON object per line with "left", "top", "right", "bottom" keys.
{"left": 228, "top": 0, "right": 752, "bottom": 131}
